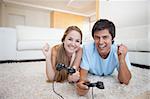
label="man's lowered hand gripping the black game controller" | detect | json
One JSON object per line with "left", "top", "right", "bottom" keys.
{"left": 76, "top": 81, "right": 89, "bottom": 96}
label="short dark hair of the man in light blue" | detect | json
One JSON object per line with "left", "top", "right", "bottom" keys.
{"left": 92, "top": 19, "right": 116, "bottom": 44}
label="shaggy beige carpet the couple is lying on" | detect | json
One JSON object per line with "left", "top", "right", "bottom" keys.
{"left": 0, "top": 62, "right": 150, "bottom": 99}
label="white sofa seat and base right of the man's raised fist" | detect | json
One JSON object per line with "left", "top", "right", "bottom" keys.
{"left": 115, "top": 39, "right": 150, "bottom": 68}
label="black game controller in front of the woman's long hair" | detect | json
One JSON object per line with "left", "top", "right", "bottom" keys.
{"left": 56, "top": 63, "right": 76, "bottom": 75}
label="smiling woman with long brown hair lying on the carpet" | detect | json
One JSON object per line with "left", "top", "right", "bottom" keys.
{"left": 43, "top": 26, "right": 82, "bottom": 82}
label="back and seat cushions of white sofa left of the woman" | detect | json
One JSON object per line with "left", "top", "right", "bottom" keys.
{"left": 16, "top": 26, "right": 64, "bottom": 50}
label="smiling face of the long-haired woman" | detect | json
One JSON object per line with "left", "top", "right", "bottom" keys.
{"left": 63, "top": 30, "right": 81, "bottom": 55}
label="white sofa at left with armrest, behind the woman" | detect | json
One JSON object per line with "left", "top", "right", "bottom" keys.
{"left": 0, "top": 26, "right": 64, "bottom": 60}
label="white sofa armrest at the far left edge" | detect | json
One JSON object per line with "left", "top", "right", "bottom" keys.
{"left": 0, "top": 27, "right": 16, "bottom": 60}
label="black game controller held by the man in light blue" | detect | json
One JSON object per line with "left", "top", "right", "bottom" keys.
{"left": 83, "top": 81, "right": 104, "bottom": 89}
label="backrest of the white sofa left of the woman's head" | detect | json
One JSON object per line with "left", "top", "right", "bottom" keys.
{"left": 16, "top": 26, "right": 64, "bottom": 41}
